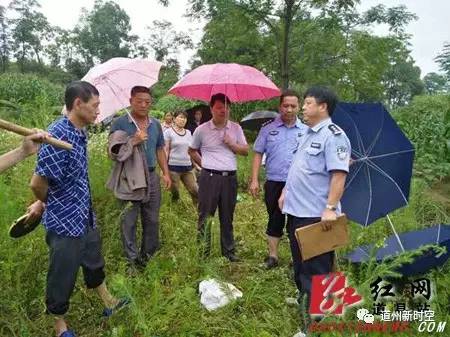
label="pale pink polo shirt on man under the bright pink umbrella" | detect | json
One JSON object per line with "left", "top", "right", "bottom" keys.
{"left": 190, "top": 119, "right": 247, "bottom": 171}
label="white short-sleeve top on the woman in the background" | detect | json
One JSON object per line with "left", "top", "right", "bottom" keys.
{"left": 164, "top": 128, "right": 192, "bottom": 166}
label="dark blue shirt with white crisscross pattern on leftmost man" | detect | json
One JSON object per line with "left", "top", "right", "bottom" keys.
{"left": 35, "top": 117, "right": 95, "bottom": 237}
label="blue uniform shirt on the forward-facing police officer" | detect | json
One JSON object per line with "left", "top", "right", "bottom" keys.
{"left": 253, "top": 116, "right": 308, "bottom": 182}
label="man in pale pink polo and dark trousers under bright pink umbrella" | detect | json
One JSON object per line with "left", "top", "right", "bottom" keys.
{"left": 189, "top": 93, "right": 248, "bottom": 262}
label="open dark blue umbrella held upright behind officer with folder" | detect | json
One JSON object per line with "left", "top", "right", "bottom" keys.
{"left": 332, "top": 103, "right": 414, "bottom": 226}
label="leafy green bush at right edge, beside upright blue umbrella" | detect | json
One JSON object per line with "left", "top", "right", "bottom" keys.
{"left": 393, "top": 96, "right": 450, "bottom": 182}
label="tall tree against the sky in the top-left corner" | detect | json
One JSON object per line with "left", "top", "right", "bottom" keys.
{"left": 9, "top": 0, "right": 50, "bottom": 71}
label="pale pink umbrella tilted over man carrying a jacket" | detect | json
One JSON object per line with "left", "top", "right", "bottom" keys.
{"left": 78, "top": 57, "right": 162, "bottom": 123}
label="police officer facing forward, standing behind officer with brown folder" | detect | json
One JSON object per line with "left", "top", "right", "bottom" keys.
{"left": 250, "top": 90, "right": 307, "bottom": 269}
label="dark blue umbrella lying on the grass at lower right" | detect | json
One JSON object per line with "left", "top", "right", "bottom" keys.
{"left": 346, "top": 225, "right": 450, "bottom": 276}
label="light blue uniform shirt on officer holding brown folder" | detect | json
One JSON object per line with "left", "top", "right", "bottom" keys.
{"left": 283, "top": 118, "right": 351, "bottom": 218}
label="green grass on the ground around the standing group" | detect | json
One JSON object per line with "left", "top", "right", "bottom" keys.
{"left": 0, "top": 131, "right": 450, "bottom": 337}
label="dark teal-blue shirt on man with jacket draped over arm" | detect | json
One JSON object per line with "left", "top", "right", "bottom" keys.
{"left": 110, "top": 114, "right": 164, "bottom": 168}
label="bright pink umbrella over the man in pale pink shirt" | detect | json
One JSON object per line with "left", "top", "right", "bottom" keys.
{"left": 169, "top": 63, "right": 280, "bottom": 102}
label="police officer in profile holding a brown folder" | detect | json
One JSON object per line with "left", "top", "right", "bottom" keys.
{"left": 279, "top": 86, "right": 351, "bottom": 330}
